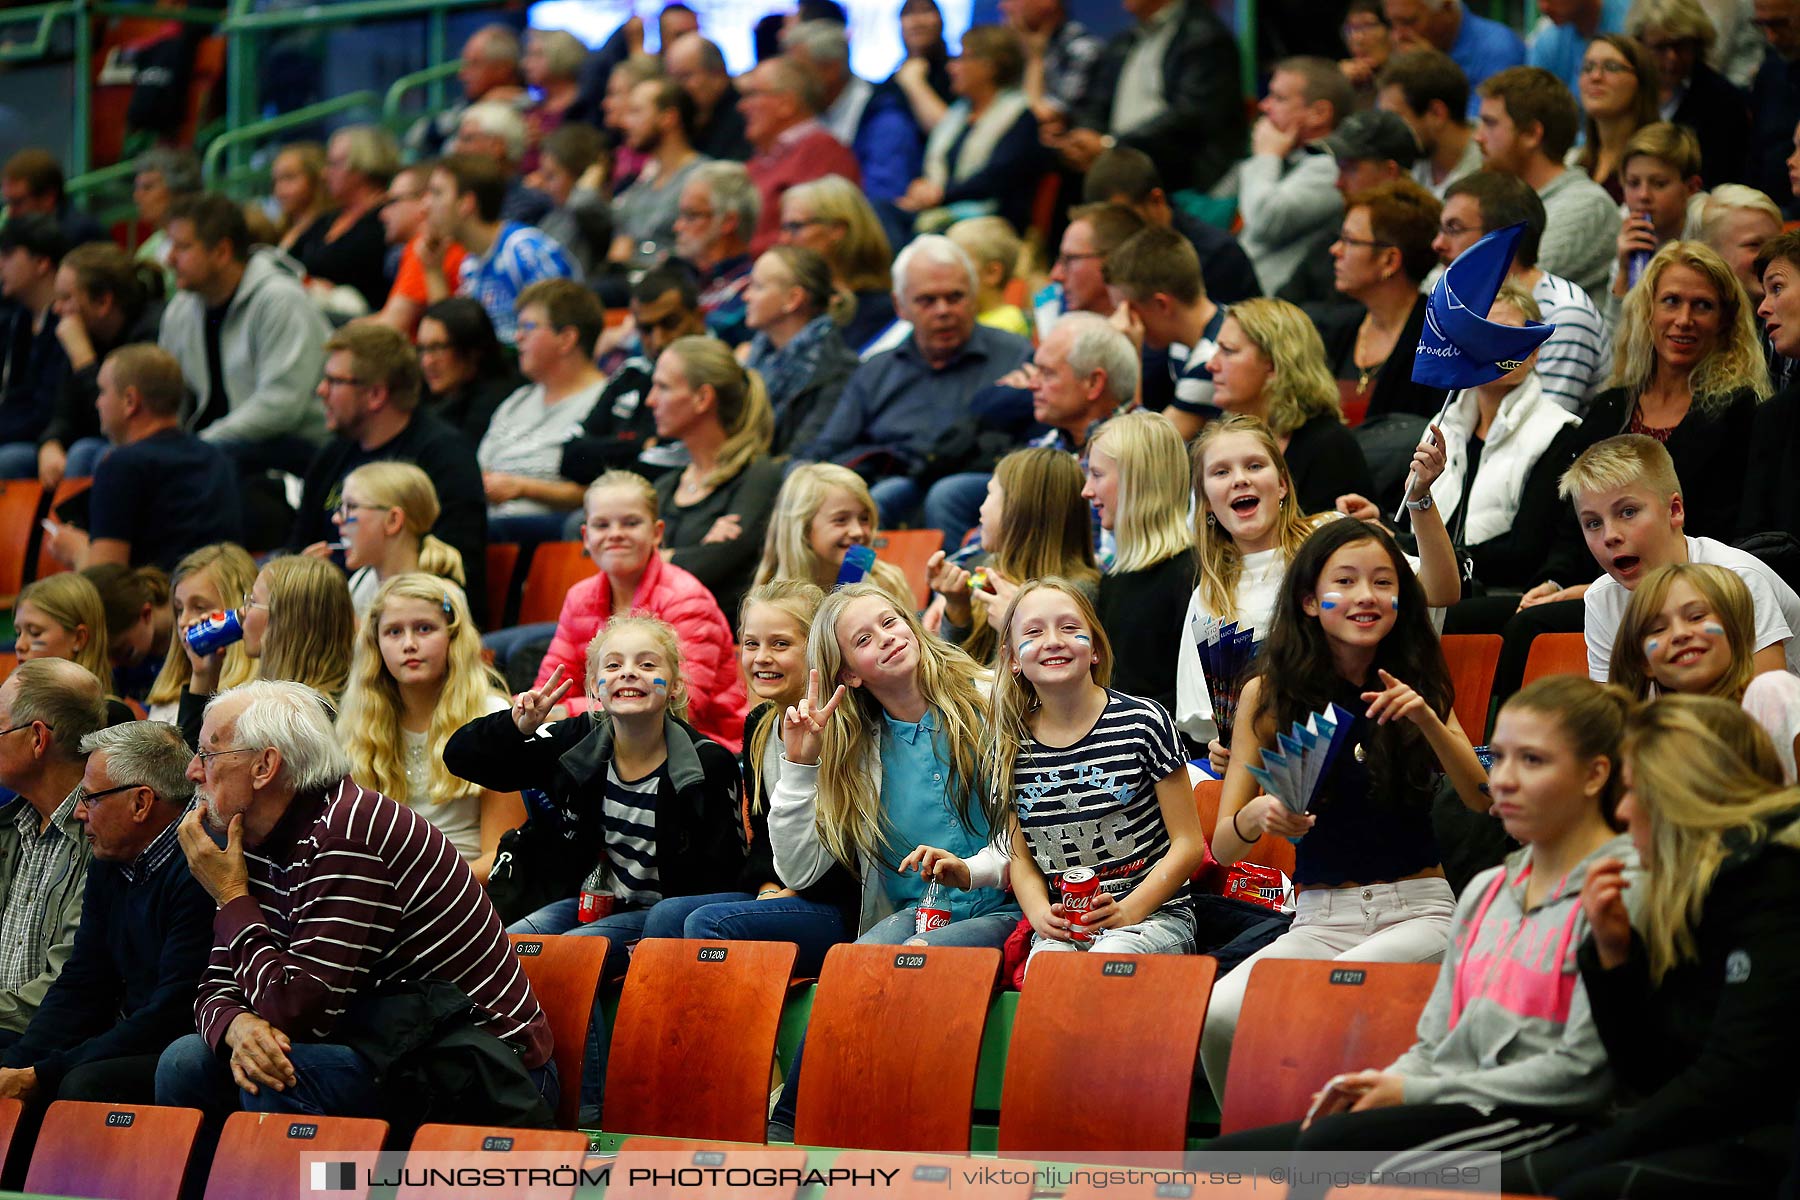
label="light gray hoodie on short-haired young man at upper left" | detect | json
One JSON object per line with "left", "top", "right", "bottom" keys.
{"left": 157, "top": 246, "right": 331, "bottom": 443}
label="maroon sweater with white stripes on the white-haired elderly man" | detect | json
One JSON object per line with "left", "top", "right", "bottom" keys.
{"left": 194, "top": 777, "right": 551, "bottom": 1069}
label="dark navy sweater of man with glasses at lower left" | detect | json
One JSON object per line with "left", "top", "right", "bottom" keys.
{"left": 0, "top": 824, "right": 216, "bottom": 1090}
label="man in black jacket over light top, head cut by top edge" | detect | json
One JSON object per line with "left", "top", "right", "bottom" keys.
{"left": 1051, "top": 0, "right": 1247, "bottom": 191}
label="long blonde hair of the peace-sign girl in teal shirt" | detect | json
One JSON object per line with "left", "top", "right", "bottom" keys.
{"left": 806, "top": 583, "right": 986, "bottom": 867}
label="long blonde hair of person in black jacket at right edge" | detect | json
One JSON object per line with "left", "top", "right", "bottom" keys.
{"left": 1624, "top": 696, "right": 1800, "bottom": 982}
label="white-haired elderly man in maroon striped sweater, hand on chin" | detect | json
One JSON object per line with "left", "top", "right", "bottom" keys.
{"left": 157, "top": 680, "right": 556, "bottom": 1126}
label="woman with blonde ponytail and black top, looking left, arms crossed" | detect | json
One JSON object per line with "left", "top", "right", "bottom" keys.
{"left": 650, "top": 336, "right": 781, "bottom": 626}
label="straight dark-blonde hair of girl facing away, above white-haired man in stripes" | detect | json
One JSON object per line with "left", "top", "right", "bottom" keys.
{"left": 256, "top": 554, "right": 356, "bottom": 703}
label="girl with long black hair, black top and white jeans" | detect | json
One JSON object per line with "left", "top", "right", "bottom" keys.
{"left": 1201, "top": 518, "right": 1490, "bottom": 1096}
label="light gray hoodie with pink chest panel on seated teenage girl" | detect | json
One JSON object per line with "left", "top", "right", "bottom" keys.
{"left": 1388, "top": 837, "right": 1643, "bottom": 1115}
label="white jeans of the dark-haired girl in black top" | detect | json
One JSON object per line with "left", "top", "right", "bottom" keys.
{"left": 1201, "top": 878, "right": 1456, "bottom": 1105}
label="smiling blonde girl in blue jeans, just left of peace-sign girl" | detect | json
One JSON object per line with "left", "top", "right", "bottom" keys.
{"left": 644, "top": 579, "right": 857, "bottom": 975}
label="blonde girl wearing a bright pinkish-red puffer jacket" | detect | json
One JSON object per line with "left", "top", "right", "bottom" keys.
{"left": 536, "top": 471, "right": 747, "bottom": 754}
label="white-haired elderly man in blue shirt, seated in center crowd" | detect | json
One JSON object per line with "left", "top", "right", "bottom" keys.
{"left": 794, "top": 234, "right": 1031, "bottom": 525}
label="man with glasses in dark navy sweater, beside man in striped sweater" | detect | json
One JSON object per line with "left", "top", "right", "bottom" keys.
{"left": 0, "top": 721, "right": 212, "bottom": 1106}
